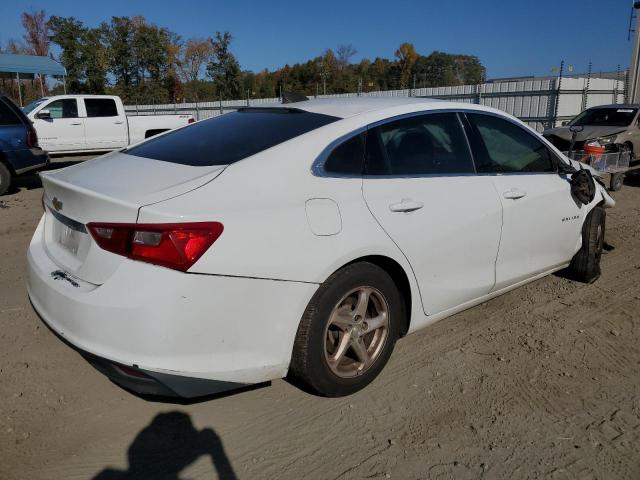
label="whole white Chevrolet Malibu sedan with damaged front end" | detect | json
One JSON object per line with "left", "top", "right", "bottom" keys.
{"left": 28, "top": 97, "right": 615, "bottom": 397}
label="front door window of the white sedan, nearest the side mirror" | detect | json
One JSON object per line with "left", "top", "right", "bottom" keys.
{"left": 467, "top": 113, "right": 555, "bottom": 173}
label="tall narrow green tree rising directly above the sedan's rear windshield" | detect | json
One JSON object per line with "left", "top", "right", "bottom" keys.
{"left": 207, "top": 32, "right": 240, "bottom": 99}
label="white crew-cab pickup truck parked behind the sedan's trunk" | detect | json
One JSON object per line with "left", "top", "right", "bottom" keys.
{"left": 23, "top": 95, "right": 195, "bottom": 153}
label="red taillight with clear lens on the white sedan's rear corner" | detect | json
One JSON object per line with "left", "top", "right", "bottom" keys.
{"left": 87, "top": 222, "right": 224, "bottom": 272}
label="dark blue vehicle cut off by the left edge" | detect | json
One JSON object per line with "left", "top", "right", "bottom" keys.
{"left": 0, "top": 95, "right": 49, "bottom": 195}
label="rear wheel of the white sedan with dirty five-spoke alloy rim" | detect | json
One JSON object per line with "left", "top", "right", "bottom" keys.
{"left": 289, "top": 262, "right": 405, "bottom": 397}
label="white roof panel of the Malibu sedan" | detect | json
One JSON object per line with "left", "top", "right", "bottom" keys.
{"left": 251, "top": 97, "right": 442, "bottom": 118}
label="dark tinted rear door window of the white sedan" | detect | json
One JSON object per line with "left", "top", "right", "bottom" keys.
{"left": 367, "top": 113, "right": 475, "bottom": 175}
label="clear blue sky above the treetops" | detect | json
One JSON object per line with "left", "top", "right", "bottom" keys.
{"left": 0, "top": 0, "right": 633, "bottom": 78}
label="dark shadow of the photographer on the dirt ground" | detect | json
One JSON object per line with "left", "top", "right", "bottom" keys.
{"left": 93, "top": 411, "right": 237, "bottom": 480}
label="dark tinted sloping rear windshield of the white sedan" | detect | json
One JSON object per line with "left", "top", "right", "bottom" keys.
{"left": 125, "top": 108, "right": 339, "bottom": 166}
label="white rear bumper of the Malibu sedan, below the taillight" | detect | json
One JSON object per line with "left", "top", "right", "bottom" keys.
{"left": 27, "top": 218, "right": 317, "bottom": 396}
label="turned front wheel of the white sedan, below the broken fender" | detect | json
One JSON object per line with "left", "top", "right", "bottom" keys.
{"left": 569, "top": 207, "right": 606, "bottom": 283}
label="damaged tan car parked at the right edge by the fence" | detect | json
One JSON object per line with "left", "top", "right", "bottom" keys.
{"left": 542, "top": 104, "right": 640, "bottom": 157}
